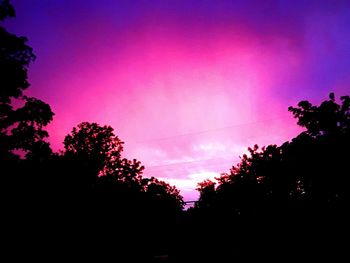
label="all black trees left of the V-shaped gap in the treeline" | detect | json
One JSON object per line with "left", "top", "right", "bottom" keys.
{"left": 0, "top": 0, "right": 184, "bottom": 262}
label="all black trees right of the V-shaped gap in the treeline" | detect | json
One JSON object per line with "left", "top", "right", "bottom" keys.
{"left": 191, "top": 93, "right": 350, "bottom": 259}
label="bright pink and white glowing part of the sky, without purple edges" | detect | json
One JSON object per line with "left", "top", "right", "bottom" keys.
{"left": 37, "top": 18, "right": 301, "bottom": 199}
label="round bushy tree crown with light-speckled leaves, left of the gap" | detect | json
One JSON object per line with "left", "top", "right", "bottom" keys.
{"left": 64, "top": 122, "right": 144, "bottom": 187}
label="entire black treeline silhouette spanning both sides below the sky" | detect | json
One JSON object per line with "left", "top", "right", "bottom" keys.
{"left": 0, "top": 0, "right": 350, "bottom": 262}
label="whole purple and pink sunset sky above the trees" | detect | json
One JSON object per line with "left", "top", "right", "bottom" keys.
{"left": 5, "top": 0, "right": 350, "bottom": 201}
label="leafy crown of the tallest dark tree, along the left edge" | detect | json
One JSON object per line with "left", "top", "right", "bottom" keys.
{"left": 0, "top": 0, "right": 54, "bottom": 160}
